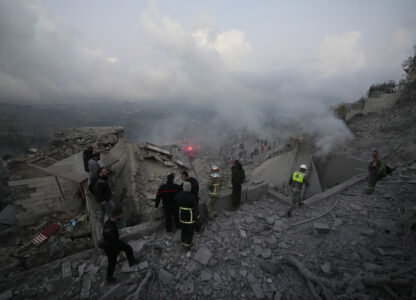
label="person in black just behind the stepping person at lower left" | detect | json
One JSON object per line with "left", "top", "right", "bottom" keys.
{"left": 94, "top": 168, "right": 115, "bottom": 226}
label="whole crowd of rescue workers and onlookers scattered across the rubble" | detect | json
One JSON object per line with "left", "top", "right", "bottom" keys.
{"left": 83, "top": 141, "right": 393, "bottom": 283}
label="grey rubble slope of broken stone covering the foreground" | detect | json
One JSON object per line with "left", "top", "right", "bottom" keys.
{"left": 0, "top": 165, "right": 416, "bottom": 299}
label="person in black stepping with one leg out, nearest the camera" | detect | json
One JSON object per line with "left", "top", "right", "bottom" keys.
{"left": 102, "top": 207, "right": 137, "bottom": 283}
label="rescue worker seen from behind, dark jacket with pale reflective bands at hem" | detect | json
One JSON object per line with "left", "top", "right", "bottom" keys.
{"left": 175, "top": 181, "right": 199, "bottom": 251}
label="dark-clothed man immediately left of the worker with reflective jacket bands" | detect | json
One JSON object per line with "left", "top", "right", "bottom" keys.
{"left": 155, "top": 173, "right": 181, "bottom": 232}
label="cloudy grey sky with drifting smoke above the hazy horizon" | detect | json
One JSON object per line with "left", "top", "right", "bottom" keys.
{"left": 0, "top": 0, "right": 416, "bottom": 152}
